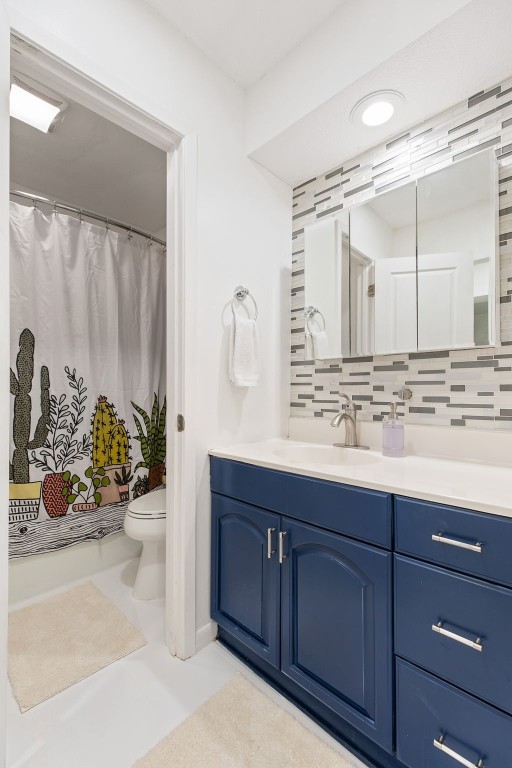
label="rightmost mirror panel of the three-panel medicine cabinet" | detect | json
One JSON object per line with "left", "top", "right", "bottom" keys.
{"left": 417, "top": 152, "right": 496, "bottom": 351}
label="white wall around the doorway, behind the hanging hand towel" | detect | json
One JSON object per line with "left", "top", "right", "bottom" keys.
{"left": 8, "top": 0, "right": 291, "bottom": 648}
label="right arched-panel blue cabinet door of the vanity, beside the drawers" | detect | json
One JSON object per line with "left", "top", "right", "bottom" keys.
{"left": 281, "top": 519, "right": 392, "bottom": 750}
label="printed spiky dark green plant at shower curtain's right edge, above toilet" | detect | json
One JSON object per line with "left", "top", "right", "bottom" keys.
{"left": 132, "top": 393, "right": 167, "bottom": 491}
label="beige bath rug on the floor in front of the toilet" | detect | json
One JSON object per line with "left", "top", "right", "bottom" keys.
{"left": 9, "top": 582, "right": 146, "bottom": 712}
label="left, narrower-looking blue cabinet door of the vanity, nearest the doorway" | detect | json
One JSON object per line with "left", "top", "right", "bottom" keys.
{"left": 211, "top": 493, "right": 279, "bottom": 667}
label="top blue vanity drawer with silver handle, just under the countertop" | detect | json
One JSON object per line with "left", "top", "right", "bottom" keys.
{"left": 395, "top": 496, "right": 512, "bottom": 586}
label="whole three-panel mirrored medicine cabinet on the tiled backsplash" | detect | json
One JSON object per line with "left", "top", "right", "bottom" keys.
{"left": 304, "top": 151, "right": 499, "bottom": 360}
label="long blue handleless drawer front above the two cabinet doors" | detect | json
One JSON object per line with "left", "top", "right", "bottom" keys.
{"left": 210, "top": 456, "right": 392, "bottom": 549}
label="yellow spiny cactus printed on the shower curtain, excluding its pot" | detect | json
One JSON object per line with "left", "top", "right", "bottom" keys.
{"left": 91, "top": 395, "right": 130, "bottom": 468}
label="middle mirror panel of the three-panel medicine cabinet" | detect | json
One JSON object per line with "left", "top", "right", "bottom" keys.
{"left": 350, "top": 183, "right": 417, "bottom": 357}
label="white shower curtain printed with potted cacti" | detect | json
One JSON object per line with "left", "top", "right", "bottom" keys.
{"left": 9, "top": 203, "right": 166, "bottom": 557}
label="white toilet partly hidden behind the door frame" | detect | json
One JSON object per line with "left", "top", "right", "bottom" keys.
{"left": 124, "top": 488, "right": 166, "bottom": 600}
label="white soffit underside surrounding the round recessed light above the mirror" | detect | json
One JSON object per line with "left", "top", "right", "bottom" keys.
{"left": 249, "top": 0, "right": 512, "bottom": 186}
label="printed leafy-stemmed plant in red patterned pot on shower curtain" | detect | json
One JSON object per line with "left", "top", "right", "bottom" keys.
{"left": 29, "top": 366, "right": 91, "bottom": 517}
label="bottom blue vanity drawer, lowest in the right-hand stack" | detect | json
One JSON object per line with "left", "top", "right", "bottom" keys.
{"left": 396, "top": 660, "right": 512, "bottom": 768}
